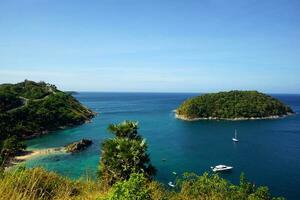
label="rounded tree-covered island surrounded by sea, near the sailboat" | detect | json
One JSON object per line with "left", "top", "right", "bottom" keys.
{"left": 176, "top": 91, "right": 293, "bottom": 121}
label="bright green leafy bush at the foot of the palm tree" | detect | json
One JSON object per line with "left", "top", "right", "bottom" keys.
{"left": 105, "top": 173, "right": 151, "bottom": 200}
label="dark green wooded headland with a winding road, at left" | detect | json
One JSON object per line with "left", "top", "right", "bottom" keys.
{"left": 0, "top": 80, "right": 94, "bottom": 166}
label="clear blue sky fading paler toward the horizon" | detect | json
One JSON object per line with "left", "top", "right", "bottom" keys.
{"left": 0, "top": 0, "right": 300, "bottom": 94}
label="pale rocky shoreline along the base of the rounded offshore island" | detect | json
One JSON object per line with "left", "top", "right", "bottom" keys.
{"left": 174, "top": 110, "right": 295, "bottom": 121}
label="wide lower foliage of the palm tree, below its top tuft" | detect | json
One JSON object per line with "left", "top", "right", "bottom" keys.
{"left": 99, "top": 138, "right": 155, "bottom": 185}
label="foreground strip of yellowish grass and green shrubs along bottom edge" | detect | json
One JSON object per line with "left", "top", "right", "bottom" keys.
{"left": 0, "top": 168, "right": 284, "bottom": 200}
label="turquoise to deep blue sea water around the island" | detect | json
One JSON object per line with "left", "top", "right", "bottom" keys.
{"left": 26, "top": 93, "right": 300, "bottom": 199}
